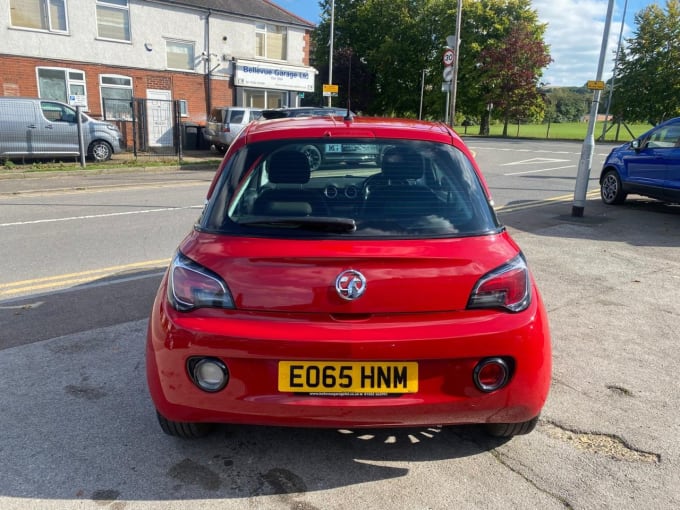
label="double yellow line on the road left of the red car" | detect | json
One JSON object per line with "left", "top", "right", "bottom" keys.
{"left": 0, "top": 259, "right": 170, "bottom": 299}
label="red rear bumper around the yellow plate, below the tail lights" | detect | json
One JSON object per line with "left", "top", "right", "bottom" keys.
{"left": 146, "top": 280, "right": 551, "bottom": 427}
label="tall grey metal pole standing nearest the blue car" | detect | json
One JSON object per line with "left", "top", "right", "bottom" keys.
{"left": 571, "top": 0, "right": 614, "bottom": 218}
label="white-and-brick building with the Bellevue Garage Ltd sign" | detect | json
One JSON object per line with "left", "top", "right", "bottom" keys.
{"left": 0, "top": 0, "right": 316, "bottom": 133}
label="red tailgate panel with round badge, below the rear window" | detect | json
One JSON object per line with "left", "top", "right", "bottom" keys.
{"left": 175, "top": 231, "right": 519, "bottom": 314}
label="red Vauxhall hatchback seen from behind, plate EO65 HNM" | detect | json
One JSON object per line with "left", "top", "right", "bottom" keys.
{"left": 146, "top": 116, "right": 551, "bottom": 438}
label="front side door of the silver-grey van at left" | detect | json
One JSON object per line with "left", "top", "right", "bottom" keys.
{"left": 38, "top": 101, "right": 80, "bottom": 155}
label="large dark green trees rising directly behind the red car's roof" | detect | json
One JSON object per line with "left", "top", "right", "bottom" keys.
{"left": 313, "top": 0, "right": 544, "bottom": 121}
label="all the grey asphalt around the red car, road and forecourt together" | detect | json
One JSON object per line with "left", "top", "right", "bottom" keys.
{"left": 0, "top": 140, "right": 680, "bottom": 510}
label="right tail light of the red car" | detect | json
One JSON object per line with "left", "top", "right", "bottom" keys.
{"left": 468, "top": 254, "right": 531, "bottom": 312}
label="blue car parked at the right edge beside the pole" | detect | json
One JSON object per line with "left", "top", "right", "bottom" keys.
{"left": 600, "top": 117, "right": 680, "bottom": 204}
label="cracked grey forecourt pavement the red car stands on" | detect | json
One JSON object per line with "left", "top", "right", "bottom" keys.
{"left": 0, "top": 165, "right": 680, "bottom": 510}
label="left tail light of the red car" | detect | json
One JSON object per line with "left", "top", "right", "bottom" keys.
{"left": 168, "top": 252, "right": 234, "bottom": 312}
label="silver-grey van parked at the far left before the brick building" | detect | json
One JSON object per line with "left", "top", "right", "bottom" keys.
{"left": 0, "top": 97, "right": 123, "bottom": 161}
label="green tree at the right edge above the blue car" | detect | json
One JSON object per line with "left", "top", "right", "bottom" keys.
{"left": 611, "top": 0, "right": 680, "bottom": 125}
